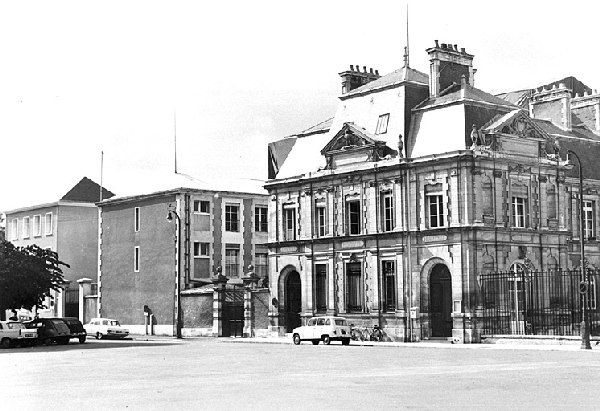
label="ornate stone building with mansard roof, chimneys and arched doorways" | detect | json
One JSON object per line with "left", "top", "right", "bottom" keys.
{"left": 266, "top": 41, "right": 600, "bottom": 343}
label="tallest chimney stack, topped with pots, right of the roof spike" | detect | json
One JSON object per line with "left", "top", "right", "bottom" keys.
{"left": 427, "top": 40, "right": 475, "bottom": 97}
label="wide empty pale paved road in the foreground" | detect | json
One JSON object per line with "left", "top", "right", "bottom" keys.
{"left": 0, "top": 338, "right": 600, "bottom": 410}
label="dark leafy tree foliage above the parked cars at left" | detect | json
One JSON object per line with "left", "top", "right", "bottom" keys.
{"left": 0, "top": 241, "right": 69, "bottom": 309}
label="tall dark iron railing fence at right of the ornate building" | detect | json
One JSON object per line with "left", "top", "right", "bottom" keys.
{"left": 478, "top": 269, "right": 600, "bottom": 335}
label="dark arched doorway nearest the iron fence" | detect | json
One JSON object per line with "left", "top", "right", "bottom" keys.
{"left": 429, "top": 264, "right": 452, "bottom": 337}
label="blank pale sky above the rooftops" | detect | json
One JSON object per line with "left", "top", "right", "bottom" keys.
{"left": 0, "top": 0, "right": 600, "bottom": 217}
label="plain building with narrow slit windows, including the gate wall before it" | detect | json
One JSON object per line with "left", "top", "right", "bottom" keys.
{"left": 98, "top": 182, "right": 268, "bottom": 337}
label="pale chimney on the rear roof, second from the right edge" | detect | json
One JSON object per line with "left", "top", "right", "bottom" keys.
{"left": 529, "top": 83, "right": 571, "bottom": 131}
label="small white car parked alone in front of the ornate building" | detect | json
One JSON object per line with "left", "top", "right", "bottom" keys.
{"left": 292, "top": 316, "right": 350, "bottom": 345}
